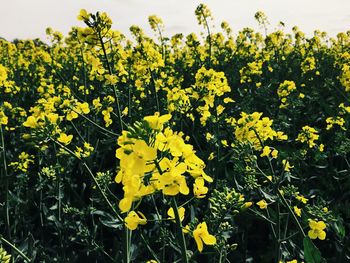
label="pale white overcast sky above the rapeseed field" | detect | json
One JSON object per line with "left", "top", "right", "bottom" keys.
{"left": 0, "top": 0, "right": 350, "bottom": 40}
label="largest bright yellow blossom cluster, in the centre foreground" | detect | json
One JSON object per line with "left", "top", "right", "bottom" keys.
{"left": 115, "top": 113, "right": 212, "bottom": 212}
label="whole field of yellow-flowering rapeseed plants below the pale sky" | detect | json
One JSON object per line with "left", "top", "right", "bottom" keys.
{"left": 0, "top": 5, "right": 350, "bottom": 263}
